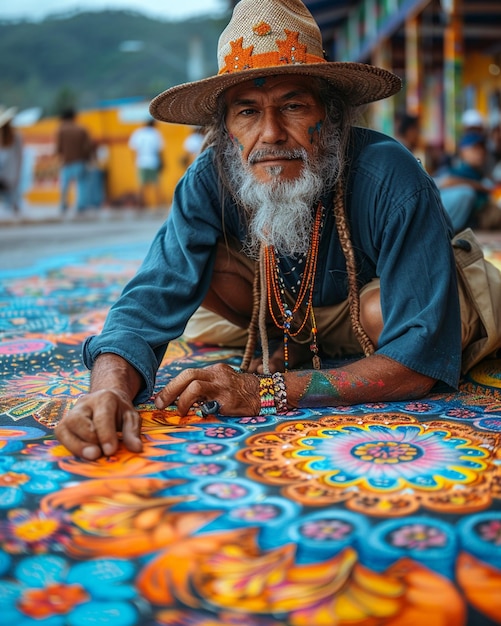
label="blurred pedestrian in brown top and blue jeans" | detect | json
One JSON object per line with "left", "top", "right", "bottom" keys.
{"left": 56, "top": 108, "right": 93, "bottom": 215}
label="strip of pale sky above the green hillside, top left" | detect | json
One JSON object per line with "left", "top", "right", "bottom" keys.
{"left": 0, "top": 0, "right": 230, "bottom": 21}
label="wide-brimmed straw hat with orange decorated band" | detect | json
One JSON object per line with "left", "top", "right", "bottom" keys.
{"left": 150, "top": 0, "right": 402, "bottom": 126}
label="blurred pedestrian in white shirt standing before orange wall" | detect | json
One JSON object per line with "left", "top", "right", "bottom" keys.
{"left": 129, "top": 119, "right": 164, "bottom": 208}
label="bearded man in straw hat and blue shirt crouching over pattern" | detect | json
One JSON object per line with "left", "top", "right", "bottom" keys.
{"left": 56, "top": 0, "right": 497, "bottom": 460}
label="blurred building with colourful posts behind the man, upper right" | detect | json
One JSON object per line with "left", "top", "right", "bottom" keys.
{"left": 296, "top": 0, "right": 501, "bottom": 163}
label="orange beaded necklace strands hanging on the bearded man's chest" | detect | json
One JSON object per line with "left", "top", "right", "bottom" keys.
{"left": 264, "top": 202, "right": 324, "bottom": 371}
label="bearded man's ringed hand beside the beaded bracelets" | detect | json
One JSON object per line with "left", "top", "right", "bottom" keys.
{"left": 155, "top": 363, "right": 261, "bottom": 415}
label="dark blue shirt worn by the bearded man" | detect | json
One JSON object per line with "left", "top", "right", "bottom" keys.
{"left": 83, "top": 128, "right": 461, "bottom": 401}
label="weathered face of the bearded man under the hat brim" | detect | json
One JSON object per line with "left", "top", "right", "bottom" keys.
{"left": 225, "top": 75, "right": 325, "bottom": 183}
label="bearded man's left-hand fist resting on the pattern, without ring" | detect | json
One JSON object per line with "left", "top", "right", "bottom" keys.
{"left": 55, "top": 389, "right": 142, "bottom": 461}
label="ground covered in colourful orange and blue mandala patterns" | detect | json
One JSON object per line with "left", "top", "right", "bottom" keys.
{"left": 0, "top": 243, "right": 501, "bottom": 626}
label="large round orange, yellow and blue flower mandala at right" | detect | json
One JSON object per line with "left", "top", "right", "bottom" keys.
{"left": 239, "top": 415, "right": 496, "bottom": 515}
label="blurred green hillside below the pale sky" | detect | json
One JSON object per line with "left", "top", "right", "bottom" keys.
{"left": 0, "top": 11, "right": 227, "bottom": 115}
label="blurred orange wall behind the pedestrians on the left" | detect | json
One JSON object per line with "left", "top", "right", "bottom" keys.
{"left": 19, "top": 108, "right": 191, "bottom": 204}
